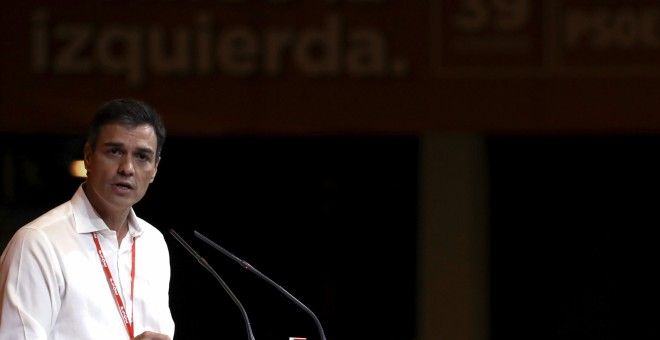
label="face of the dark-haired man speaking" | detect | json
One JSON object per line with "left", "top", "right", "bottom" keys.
{"left": 85, "top": 124, "right": 160, "bottom": 216}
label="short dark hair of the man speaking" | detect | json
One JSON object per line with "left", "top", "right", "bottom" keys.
{"left": 87, "top": 98, "right": 167, "bottom": 160}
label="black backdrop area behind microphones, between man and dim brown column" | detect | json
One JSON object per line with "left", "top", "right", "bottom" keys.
{"left": 147, "top": 137, "right": 417, "bottom": 339}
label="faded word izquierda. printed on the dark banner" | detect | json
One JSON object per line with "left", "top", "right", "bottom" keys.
{"left": 31, "top": 9, "right": 408, "bottom": 86}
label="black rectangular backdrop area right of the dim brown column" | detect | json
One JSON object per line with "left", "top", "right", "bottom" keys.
{"left": 489, "top": 135, "right": 660, "bottom": 339}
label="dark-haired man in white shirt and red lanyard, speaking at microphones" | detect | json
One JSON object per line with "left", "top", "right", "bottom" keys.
{"left": 0, "top": 99, "right": 174, "bottom": 340}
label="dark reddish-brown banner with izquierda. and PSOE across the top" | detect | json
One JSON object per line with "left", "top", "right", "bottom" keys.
{"left": 0, "top": 0, "right": 660, "bottom": 135}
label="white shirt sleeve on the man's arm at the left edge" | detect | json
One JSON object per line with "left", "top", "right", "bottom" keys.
{"left": 0, "top": 227, "right": 61, "bottom": 340}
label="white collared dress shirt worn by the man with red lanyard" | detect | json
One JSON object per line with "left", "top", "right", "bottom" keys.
{"left": 0, "top": 185, "right": 174, "bottom": 340}
